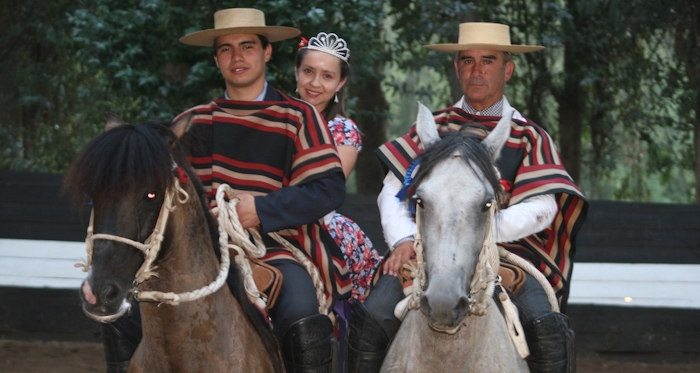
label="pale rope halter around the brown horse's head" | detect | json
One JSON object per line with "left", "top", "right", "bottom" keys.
{"left": 75, "top": 178, "right": 231, "bottom": 306}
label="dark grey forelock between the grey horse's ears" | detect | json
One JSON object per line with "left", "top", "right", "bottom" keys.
{"left": 407, "top": 129, "right": 503, "bottom": 204}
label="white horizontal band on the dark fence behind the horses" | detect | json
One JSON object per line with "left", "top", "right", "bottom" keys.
{"left": 5, "top": 239, "right": 700, "bottom": 309}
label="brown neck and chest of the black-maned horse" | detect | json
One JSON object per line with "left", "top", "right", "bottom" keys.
{"left": 132, "top": 198, "right": 272, "bottom": 372}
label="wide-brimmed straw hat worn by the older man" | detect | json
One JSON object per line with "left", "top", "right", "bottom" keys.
{"left": 423, "top": 22, "right": 544, "bottom": 53}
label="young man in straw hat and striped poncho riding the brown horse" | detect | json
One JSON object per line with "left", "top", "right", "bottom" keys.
{"left": 105, "top": 8, "right": 351, "bottom": 372}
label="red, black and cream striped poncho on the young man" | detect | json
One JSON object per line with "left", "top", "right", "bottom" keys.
{"left": 181, "top": 87, "right": 351, "bottom": 305}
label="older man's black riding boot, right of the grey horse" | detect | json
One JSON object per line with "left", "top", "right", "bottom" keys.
{"left": 523, "top": 312, "right": 576, "bottom": 373}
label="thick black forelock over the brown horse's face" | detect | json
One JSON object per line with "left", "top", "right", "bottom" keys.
{"left": 64, "top": 122, "right": 174, "bottom": 203}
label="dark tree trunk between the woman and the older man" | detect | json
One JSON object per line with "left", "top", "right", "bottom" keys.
{"left": 350, "top": 79, "right": 389, "bottom": 194}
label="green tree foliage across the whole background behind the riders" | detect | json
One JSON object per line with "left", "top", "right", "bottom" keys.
{"left": 0, "top": 0, "right": 700, "bottom": 202}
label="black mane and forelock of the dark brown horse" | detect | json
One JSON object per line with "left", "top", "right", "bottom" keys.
{"left": 63, "top": 122, "right": 284, "bottom": 372}
